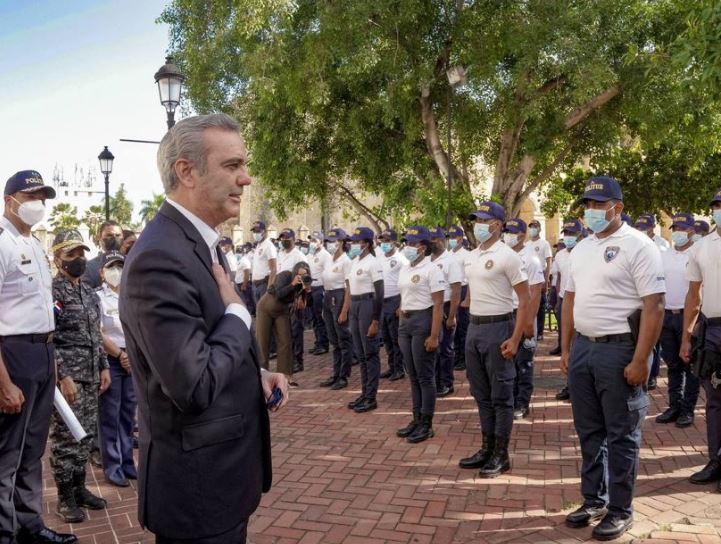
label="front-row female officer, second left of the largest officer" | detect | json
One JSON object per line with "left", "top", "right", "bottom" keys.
{"left": 396, "top": 226, "right": 447, "bottom": 444}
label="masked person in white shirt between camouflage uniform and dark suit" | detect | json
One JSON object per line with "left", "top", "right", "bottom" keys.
{"left": 98, "top": 251, "right": 138, "bottom": 487}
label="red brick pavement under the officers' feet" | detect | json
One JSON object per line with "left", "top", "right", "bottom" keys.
{"left": 38, "top": 335, "right": 721, "bottom": 544}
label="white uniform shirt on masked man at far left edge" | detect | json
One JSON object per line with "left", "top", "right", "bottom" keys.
{"left": 0, "top": 217, "right": 55, "bottom": 336}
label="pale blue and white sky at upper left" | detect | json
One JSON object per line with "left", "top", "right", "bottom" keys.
{"left": 0, "top": 0, "right": 179, "bottom": 221}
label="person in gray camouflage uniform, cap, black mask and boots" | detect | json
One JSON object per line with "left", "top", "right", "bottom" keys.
{"left": 50, "top": 230, "right": 110, "bottom": 523}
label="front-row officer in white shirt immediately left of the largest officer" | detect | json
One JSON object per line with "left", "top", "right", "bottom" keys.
{"left": 459, "top": 201, "right": 534, "bottom": 478}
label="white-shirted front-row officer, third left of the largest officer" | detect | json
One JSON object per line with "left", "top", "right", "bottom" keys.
{"left": 338, "top": 227, "right": 383, "bottom": 413}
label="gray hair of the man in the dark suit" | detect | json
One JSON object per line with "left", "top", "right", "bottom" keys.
{"left": 158, "top": 113, "right": 240, "bottom": 194}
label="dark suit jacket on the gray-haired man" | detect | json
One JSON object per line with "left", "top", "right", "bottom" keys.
{"left": 120, "top": 203, "right": 271, "bottom": 539}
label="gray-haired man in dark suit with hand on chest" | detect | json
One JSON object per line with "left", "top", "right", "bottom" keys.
{"left": 120, "top": 114, "right": 288, "bottom": 544}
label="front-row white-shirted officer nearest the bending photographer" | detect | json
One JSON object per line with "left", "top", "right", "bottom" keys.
{"left": 320, "top": 228, "right": 353, "bottom": 391}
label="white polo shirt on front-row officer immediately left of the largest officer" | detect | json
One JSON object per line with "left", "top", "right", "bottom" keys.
{"left": 466, "top": 240, "right": 528, "bottom": 316}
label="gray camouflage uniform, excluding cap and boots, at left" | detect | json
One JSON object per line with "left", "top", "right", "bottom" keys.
{"left": 50, "top": 274, "right": 109, "bottom": 486}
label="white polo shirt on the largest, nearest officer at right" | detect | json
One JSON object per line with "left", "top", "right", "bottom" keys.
{"left": 566, "top": 223, "right": 666, "bottom": 336}
